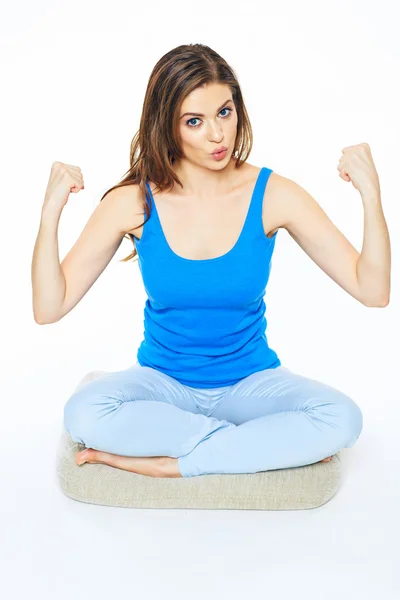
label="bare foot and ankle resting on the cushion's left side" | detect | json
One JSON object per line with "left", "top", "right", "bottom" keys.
{"left": 75, "top": 448, "right": 181, "bottom": 477}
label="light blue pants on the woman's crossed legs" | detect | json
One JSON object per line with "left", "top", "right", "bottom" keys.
{"left": 64, "top": 363, "right": 363, "bottom": 477}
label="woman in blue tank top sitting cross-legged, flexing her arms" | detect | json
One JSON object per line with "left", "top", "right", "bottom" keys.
{"left": 33, "top": 44, "right": 387, "bottom": 477}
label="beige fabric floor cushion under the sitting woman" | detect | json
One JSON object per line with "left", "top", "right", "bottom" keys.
{"left": 57, "top": 371, "right": 340, "bottom": 510}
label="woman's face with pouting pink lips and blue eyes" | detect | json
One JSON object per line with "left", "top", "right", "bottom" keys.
{"left": 179, "top": 83, "right": 238, "bottom": 169}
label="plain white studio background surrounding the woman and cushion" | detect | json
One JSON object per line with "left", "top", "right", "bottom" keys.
{"left": 0, "top": 0, "right": 400, "bottom": 600}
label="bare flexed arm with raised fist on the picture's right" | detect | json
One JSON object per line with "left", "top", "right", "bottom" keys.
{"left": 268, "top": 144, "right": 390, "bottom": 307}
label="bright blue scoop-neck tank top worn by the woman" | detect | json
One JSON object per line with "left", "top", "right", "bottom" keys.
{"left": 134, "top": 167, "right": 281, "bottom": 388}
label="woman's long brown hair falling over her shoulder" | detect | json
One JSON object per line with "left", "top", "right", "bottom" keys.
{"left": 100, "top": 44, "right": 253, "bottom": 262}
